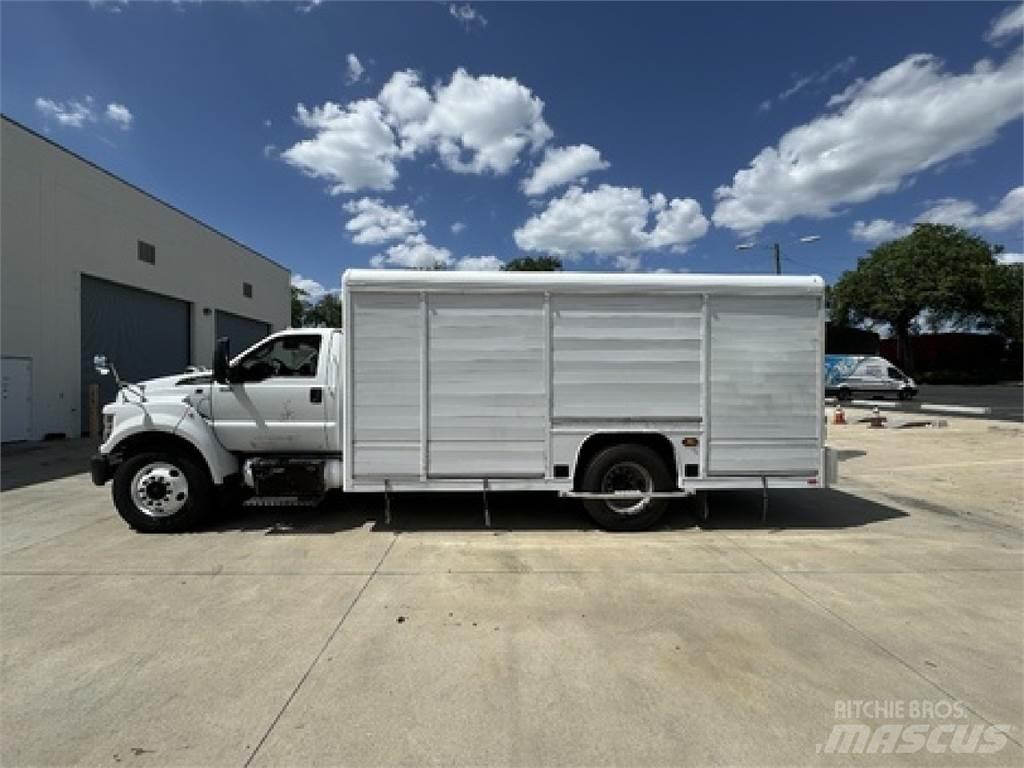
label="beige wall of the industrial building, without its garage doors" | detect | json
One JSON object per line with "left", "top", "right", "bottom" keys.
{"left": 0, "top": 119, "right": 291, "bottom": 438}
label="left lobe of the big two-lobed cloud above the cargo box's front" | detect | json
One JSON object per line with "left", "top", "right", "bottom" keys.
{"left": 282, "top": 98, "right": 398, "bottom": 195}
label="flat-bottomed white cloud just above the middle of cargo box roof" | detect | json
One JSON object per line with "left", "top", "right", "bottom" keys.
{"left": 515, "top": 184, "right": 708, "bottom": 257}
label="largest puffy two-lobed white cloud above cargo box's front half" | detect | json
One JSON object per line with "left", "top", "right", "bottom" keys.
{"left": 283, "top": 69, "right": 552, "bottom": 194}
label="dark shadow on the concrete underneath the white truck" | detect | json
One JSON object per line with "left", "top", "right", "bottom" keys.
{"left": 207, "top": 489, "right": 906, "bottom": 536}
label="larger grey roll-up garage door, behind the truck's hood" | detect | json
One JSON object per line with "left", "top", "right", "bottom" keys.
{"left": 81, "top": 274, "right": 189, "bottom": 433}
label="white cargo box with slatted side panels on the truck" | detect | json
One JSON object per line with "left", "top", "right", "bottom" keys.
{"left": 343, "top": 270, "right": 825, "bottom": 490}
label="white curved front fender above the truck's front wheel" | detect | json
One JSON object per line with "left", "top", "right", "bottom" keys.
{"left": 99, "top": 401, "right": 240, "bottom": 485}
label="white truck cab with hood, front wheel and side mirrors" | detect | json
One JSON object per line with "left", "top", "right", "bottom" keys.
{"left": 91, "top": 329, "right": 343, "bottom": 532}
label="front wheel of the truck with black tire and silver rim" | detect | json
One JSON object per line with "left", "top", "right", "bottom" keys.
{"left": 112, "top": 451, "right": 214, "bottom": 534}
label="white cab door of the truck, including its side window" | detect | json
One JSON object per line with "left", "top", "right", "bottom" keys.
{"left": 211, "top": 333, "right": 328, "bottom": 454}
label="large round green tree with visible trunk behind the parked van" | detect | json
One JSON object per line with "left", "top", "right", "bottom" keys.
{"left": 831, "top": 224, "right": 1006, "bottom": 372}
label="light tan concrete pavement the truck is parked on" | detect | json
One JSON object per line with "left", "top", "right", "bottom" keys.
{"left": 0, "top": 430, "right": 1024, "bottom": 766}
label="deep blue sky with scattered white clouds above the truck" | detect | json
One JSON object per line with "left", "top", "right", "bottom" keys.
{"left": 0, "top": 2, "right": 1024, "bottom": 291}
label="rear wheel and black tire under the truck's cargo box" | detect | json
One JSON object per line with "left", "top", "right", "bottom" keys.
{"left": 582, "top": 443, "right": 675, "bottom": 530}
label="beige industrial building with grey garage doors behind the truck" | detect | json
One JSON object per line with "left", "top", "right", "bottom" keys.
{"left": 0, "top": 117, "right": 291, "bottom": 442}
